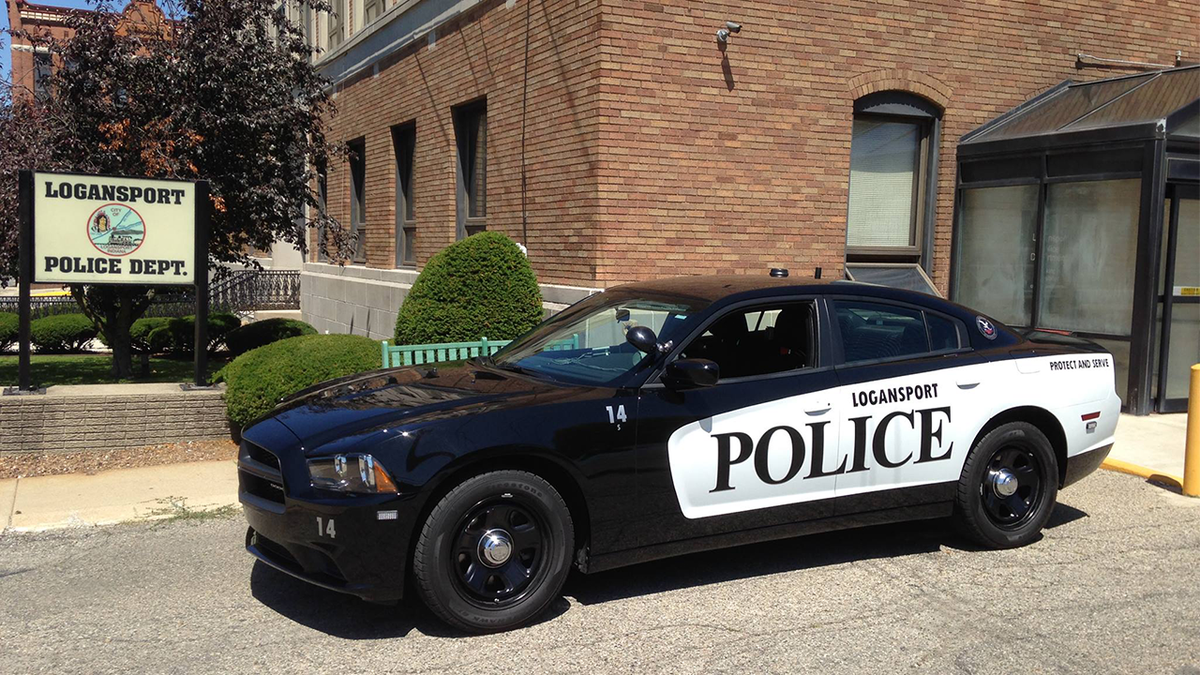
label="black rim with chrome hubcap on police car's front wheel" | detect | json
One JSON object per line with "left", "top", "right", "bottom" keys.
{"left": 450, "top": 495, "right": 547, "bottom": 609}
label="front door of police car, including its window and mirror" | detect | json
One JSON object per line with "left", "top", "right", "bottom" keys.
{"left": 630, "top": 298, "right": 839, "bottom": 545}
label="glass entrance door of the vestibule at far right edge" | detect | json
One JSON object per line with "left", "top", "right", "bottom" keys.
{"left": 1156, "top": 184, "right": 1200, "bottom": 412}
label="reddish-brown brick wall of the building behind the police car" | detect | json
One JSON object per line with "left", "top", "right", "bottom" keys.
{"left": 321, "top": 0, "right": 1200, "bottom": 291}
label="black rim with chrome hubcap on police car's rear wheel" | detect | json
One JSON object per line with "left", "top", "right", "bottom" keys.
{"left": 979, "top": 446, "right": 1044, "bottom": 530}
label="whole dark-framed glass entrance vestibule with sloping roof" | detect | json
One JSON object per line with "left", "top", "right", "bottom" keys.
{"left": 950, "top": 66, "right": 1200, "bottom": 414}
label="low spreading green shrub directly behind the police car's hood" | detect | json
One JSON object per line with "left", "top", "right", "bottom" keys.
{"left": 216, "top": 335, "right": 379, "bottom": 426}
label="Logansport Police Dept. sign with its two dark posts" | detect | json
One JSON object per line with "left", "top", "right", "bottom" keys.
{"left": 10, "top": 171, "right": 211, "bottom": 392}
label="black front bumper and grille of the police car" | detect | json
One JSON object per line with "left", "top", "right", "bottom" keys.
{"left": 238, "top": 432, "right": 414, "bottom": 602}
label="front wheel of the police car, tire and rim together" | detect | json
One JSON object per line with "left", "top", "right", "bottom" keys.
{"left": 413, "top": 471, "right": 575, "bottom": 633}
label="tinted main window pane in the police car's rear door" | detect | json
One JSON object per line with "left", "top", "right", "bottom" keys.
{"left": 833, "top": 300, "right": 931, "bottom": 363}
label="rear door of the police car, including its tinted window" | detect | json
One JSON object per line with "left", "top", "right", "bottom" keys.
{"left": 829, "top": 298, "right": 995, "bottom": 514}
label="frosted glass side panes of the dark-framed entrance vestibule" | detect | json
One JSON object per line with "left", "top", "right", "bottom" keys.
{"left": 954, "top": 172, "right": 1141, "bottom": 394}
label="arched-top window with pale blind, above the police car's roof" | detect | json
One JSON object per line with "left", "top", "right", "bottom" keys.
{"left": 846, "top": 91, "right": 942, "bottom": 264}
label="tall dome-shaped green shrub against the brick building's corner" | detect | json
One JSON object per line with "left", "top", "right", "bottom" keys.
{"left": 396, "top": 232, "right": 542, "bottom": 345}
